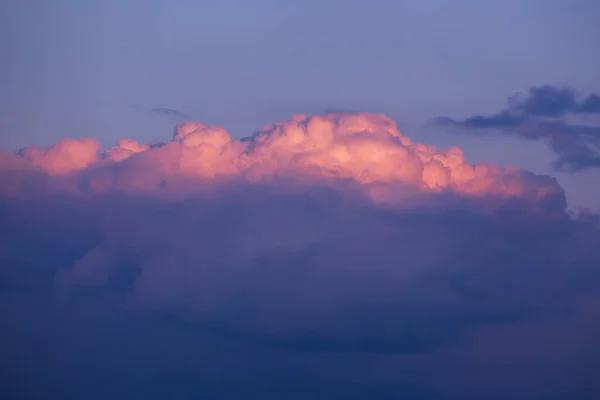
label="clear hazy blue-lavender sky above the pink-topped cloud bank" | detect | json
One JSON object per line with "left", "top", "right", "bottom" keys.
{"left": 0, "top": 0, "right": 600, "bottom": 207}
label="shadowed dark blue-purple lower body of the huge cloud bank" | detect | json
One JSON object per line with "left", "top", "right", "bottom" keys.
{"left": 0, "top": 171, "right": 600, "bottom": 399}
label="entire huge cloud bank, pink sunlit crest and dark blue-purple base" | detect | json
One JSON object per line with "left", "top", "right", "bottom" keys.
{"left": 0, "top": 114, "right": 600, "bottom": 399}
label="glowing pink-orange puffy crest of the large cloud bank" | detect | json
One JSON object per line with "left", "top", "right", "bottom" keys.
{"left": 1, "top": 113, "right": 560, "bottom": 206}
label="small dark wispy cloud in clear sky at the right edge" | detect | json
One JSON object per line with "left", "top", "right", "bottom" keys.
{"left": 434, "top": 85, "right": 600, "bottom": 171}
